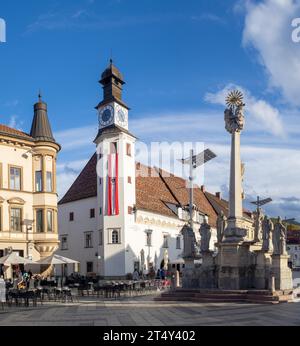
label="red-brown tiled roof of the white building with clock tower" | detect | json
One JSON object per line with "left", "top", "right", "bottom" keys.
{"left": 59, "top": 154, "right": 217, "bottom": 225}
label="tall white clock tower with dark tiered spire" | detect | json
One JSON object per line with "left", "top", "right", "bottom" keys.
{"left": 94, "top": 60, "right": 136, "bottom": 278}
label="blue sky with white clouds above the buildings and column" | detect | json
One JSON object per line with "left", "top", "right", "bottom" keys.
{"left": 0, "top": 0, "right": 300, "bottom": 218}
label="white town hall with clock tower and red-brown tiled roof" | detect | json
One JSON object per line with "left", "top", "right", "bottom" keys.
{"left": 58, "top": 61, "right": 247, "bottom": 278}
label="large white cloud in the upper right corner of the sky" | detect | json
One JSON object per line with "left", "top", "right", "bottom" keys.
{"left": 243, "top": 0, "right": 300, "bottom": 106}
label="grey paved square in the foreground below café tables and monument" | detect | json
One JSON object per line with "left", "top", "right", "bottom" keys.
{"left": 0, "top": 296, "right": 300, "bottom": 326}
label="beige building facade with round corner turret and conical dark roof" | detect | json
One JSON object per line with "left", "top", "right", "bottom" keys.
{"left": 0, "top": 98, "right": 60, "bottom": 274}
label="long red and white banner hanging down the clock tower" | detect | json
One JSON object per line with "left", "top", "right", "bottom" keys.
{"left": 107, "top": 153, "right": 119, "bottom": 216}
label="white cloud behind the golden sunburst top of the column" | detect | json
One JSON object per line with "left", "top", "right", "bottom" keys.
{"left": 204, "top": 84, "right": 286, "bottom": 137}
